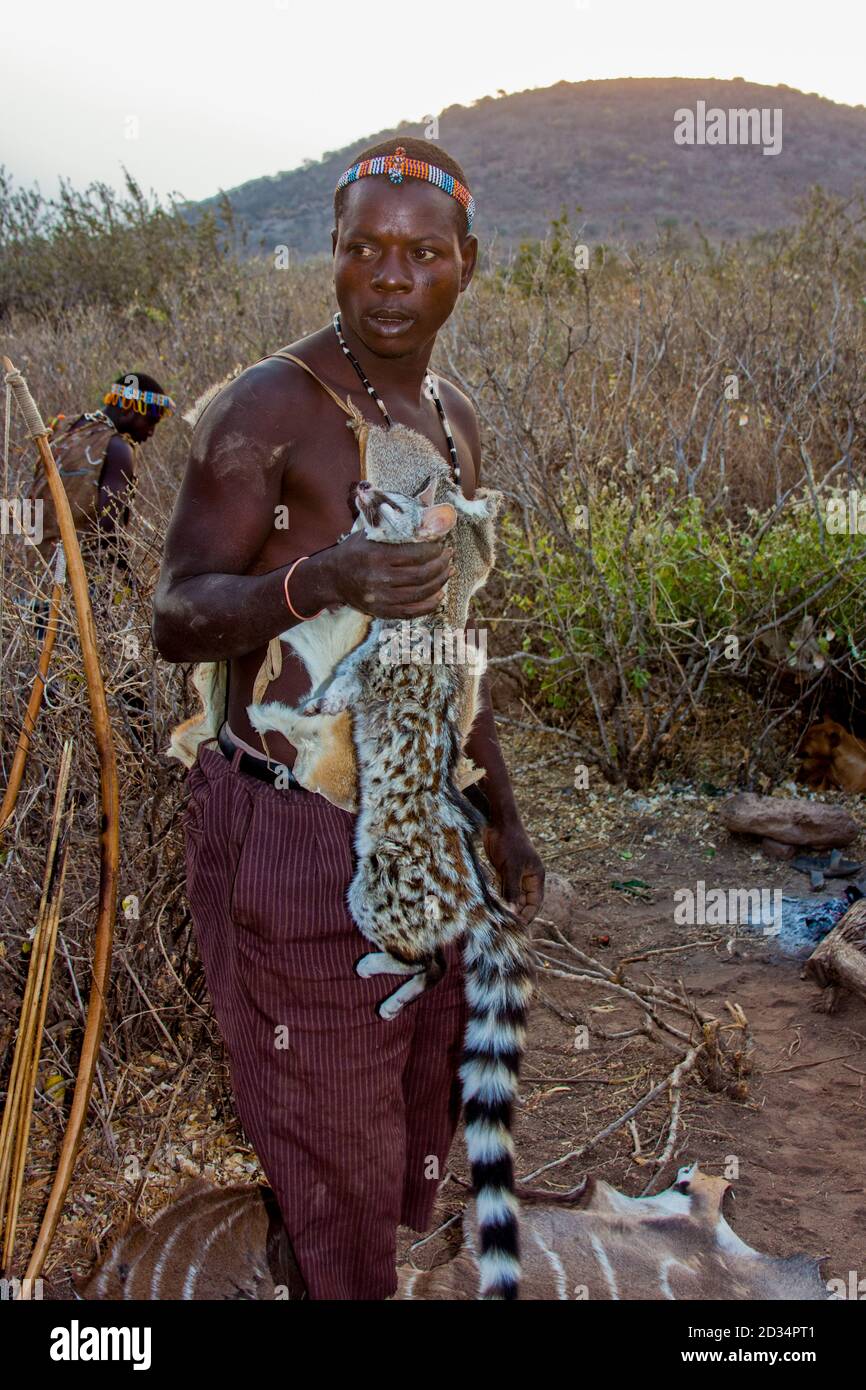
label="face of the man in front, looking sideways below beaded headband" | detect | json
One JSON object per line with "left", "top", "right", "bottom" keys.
{"left": 331, "top": 177, "right": 478, "bottom": 357}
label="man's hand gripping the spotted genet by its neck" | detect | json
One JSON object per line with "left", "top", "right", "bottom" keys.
{"left": 328, "top": 531, "right": 455, "bottom": 617}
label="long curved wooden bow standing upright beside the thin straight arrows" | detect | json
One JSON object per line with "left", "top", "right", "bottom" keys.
{"left": 3, "top": 357, "right": 120, "bottom": 1279}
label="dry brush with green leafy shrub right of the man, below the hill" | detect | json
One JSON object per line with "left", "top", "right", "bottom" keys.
{"left": 441, "top": 193, "right": 866, "bottom": 787}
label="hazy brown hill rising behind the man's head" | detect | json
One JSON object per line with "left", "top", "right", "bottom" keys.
{"left": 196, "top": 78, "right": 866, "bottom": 256}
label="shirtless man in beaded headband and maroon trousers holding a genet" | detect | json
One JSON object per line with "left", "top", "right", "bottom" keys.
{"left": 153, "top": 139, "right": 544, "bottom": 1300}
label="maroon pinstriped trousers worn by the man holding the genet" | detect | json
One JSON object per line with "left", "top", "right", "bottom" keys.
{"left": 185, "top": 745, "right": 466, "bottom": 1300}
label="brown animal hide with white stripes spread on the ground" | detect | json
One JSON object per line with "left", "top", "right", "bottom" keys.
{"left": 79, "top": 1165, "right": 831, "bottom": 1302}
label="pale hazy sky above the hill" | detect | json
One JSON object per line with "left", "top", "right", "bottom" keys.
{"left": 0, "top": 0, "right": 866, "bottom": 197}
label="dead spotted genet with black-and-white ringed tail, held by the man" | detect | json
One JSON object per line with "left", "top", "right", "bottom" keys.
{"left": 249, "top": 480, "right": 531, "bottom": 1298}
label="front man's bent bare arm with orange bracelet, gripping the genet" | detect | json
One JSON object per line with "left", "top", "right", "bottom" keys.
{"left": 153, "top": 363, "right": 450, "bottom": 662}
